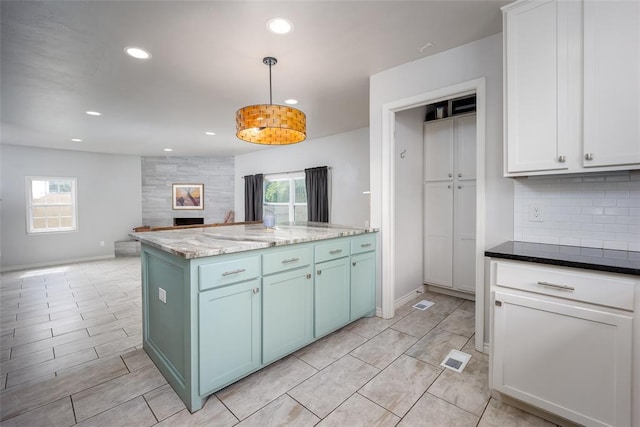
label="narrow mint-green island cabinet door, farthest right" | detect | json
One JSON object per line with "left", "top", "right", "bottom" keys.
{"left": 351, "top": 252, "right": 376, "bottom": 320}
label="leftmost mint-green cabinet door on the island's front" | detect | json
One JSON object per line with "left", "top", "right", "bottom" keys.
{"left": 198, "top": 279, "right": 261, "bottom": 395}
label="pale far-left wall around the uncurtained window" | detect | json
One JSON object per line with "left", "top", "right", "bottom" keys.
{"left": 0, "top": 145, "right": 141, "bottom": 271}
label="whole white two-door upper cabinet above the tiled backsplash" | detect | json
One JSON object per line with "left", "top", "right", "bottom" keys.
{"left": 502, "top": 0, "right": 640, "bottom": 176}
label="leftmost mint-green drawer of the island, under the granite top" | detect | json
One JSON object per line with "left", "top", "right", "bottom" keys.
{"left": 198, "top": 255, "right": 260, "bottom": 291}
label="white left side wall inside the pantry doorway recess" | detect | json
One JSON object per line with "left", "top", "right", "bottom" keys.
{"left": 394, "top": 107, "right": 427, "bottom": 299}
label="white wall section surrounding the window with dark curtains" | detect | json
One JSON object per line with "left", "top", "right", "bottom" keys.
{"left": 234, "top": 128, "right": 369, "bottom": 227}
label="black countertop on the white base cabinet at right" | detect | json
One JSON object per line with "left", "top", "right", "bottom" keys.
{"left": 484, "top": 241, "right": 640, "bottom": 276}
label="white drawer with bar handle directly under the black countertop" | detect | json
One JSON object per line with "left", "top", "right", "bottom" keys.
{"left": 494, "top": 261, "right": 635, "bottom": 311}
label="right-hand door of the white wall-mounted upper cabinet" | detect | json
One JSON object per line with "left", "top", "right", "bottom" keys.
{"left": 583, "top": 0, "right": 640, "bottom": 167}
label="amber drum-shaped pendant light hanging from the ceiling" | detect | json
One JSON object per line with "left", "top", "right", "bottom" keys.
{"left": 236, "top": 56, "right": 307, "bottom": 145}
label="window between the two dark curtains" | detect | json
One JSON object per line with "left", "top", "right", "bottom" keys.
{"left": 263, "top": 172, "right": 307, "bottom": 224}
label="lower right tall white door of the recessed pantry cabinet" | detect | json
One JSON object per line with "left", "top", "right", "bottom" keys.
{"left": 453, "top": 181, "right": 476, "bottom": 292}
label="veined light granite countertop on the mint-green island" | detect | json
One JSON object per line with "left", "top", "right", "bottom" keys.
{"left": 129, "top": 222, "right": 377, "bottom": 259}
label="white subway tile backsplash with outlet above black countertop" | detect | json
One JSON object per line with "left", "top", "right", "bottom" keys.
{"left": 514, "top": 171, "right": 640, "bottom": 251}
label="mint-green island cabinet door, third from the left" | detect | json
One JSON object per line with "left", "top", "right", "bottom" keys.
{"left": 315, "top": 258, "right": 350, "bottom": 338}
